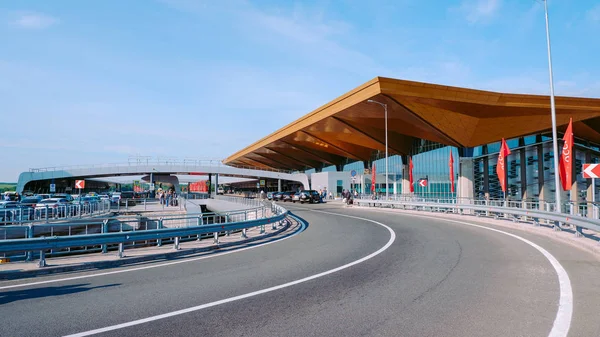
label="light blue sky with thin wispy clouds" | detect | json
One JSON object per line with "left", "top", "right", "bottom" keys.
{"left": 0, "top": 0, "right": 600, "bottom": 181}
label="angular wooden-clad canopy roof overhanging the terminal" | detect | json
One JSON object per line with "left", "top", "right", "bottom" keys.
{"left": 224, "top": 77, "right": 600, "bottom": 170}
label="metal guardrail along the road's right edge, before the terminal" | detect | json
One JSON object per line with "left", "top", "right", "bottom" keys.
{"left": 354, "top": 199, "right": 600, "bottom": 236}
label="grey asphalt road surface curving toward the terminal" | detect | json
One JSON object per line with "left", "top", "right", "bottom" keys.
{"left": 0, "top": 203, "right": 600, "bottom": 336}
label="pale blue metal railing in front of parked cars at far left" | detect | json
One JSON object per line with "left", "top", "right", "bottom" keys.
{"left": 0, "top": 200, "right": 111, "bottom": 225}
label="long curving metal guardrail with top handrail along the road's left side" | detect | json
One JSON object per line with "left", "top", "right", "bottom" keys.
{"left": 0, "top": 201, "right": 288, "bottom": 267}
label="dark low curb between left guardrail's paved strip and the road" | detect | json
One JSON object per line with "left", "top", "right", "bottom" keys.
{"left": 0, "top": 217, "right": 291, "bottom": 280}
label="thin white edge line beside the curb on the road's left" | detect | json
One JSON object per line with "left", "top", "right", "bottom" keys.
{"left": 0, "top": 218, "right": 302, "bottom": 290}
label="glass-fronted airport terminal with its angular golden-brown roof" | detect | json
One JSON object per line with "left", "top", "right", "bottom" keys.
{"left": 224, "top": 77, "right": 600, "bottom": 207}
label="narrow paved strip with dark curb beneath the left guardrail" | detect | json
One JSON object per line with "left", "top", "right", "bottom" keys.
{"left": 0, "top": 218, "right": 300, "bottom": 280}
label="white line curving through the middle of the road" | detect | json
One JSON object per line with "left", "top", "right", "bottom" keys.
{"left": 65, "top": 211, "right": 396, "bottom": 337}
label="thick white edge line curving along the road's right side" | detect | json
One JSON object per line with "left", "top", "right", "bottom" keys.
{"left": 358, "top": 211, "right": 573, "bottom": 337}
